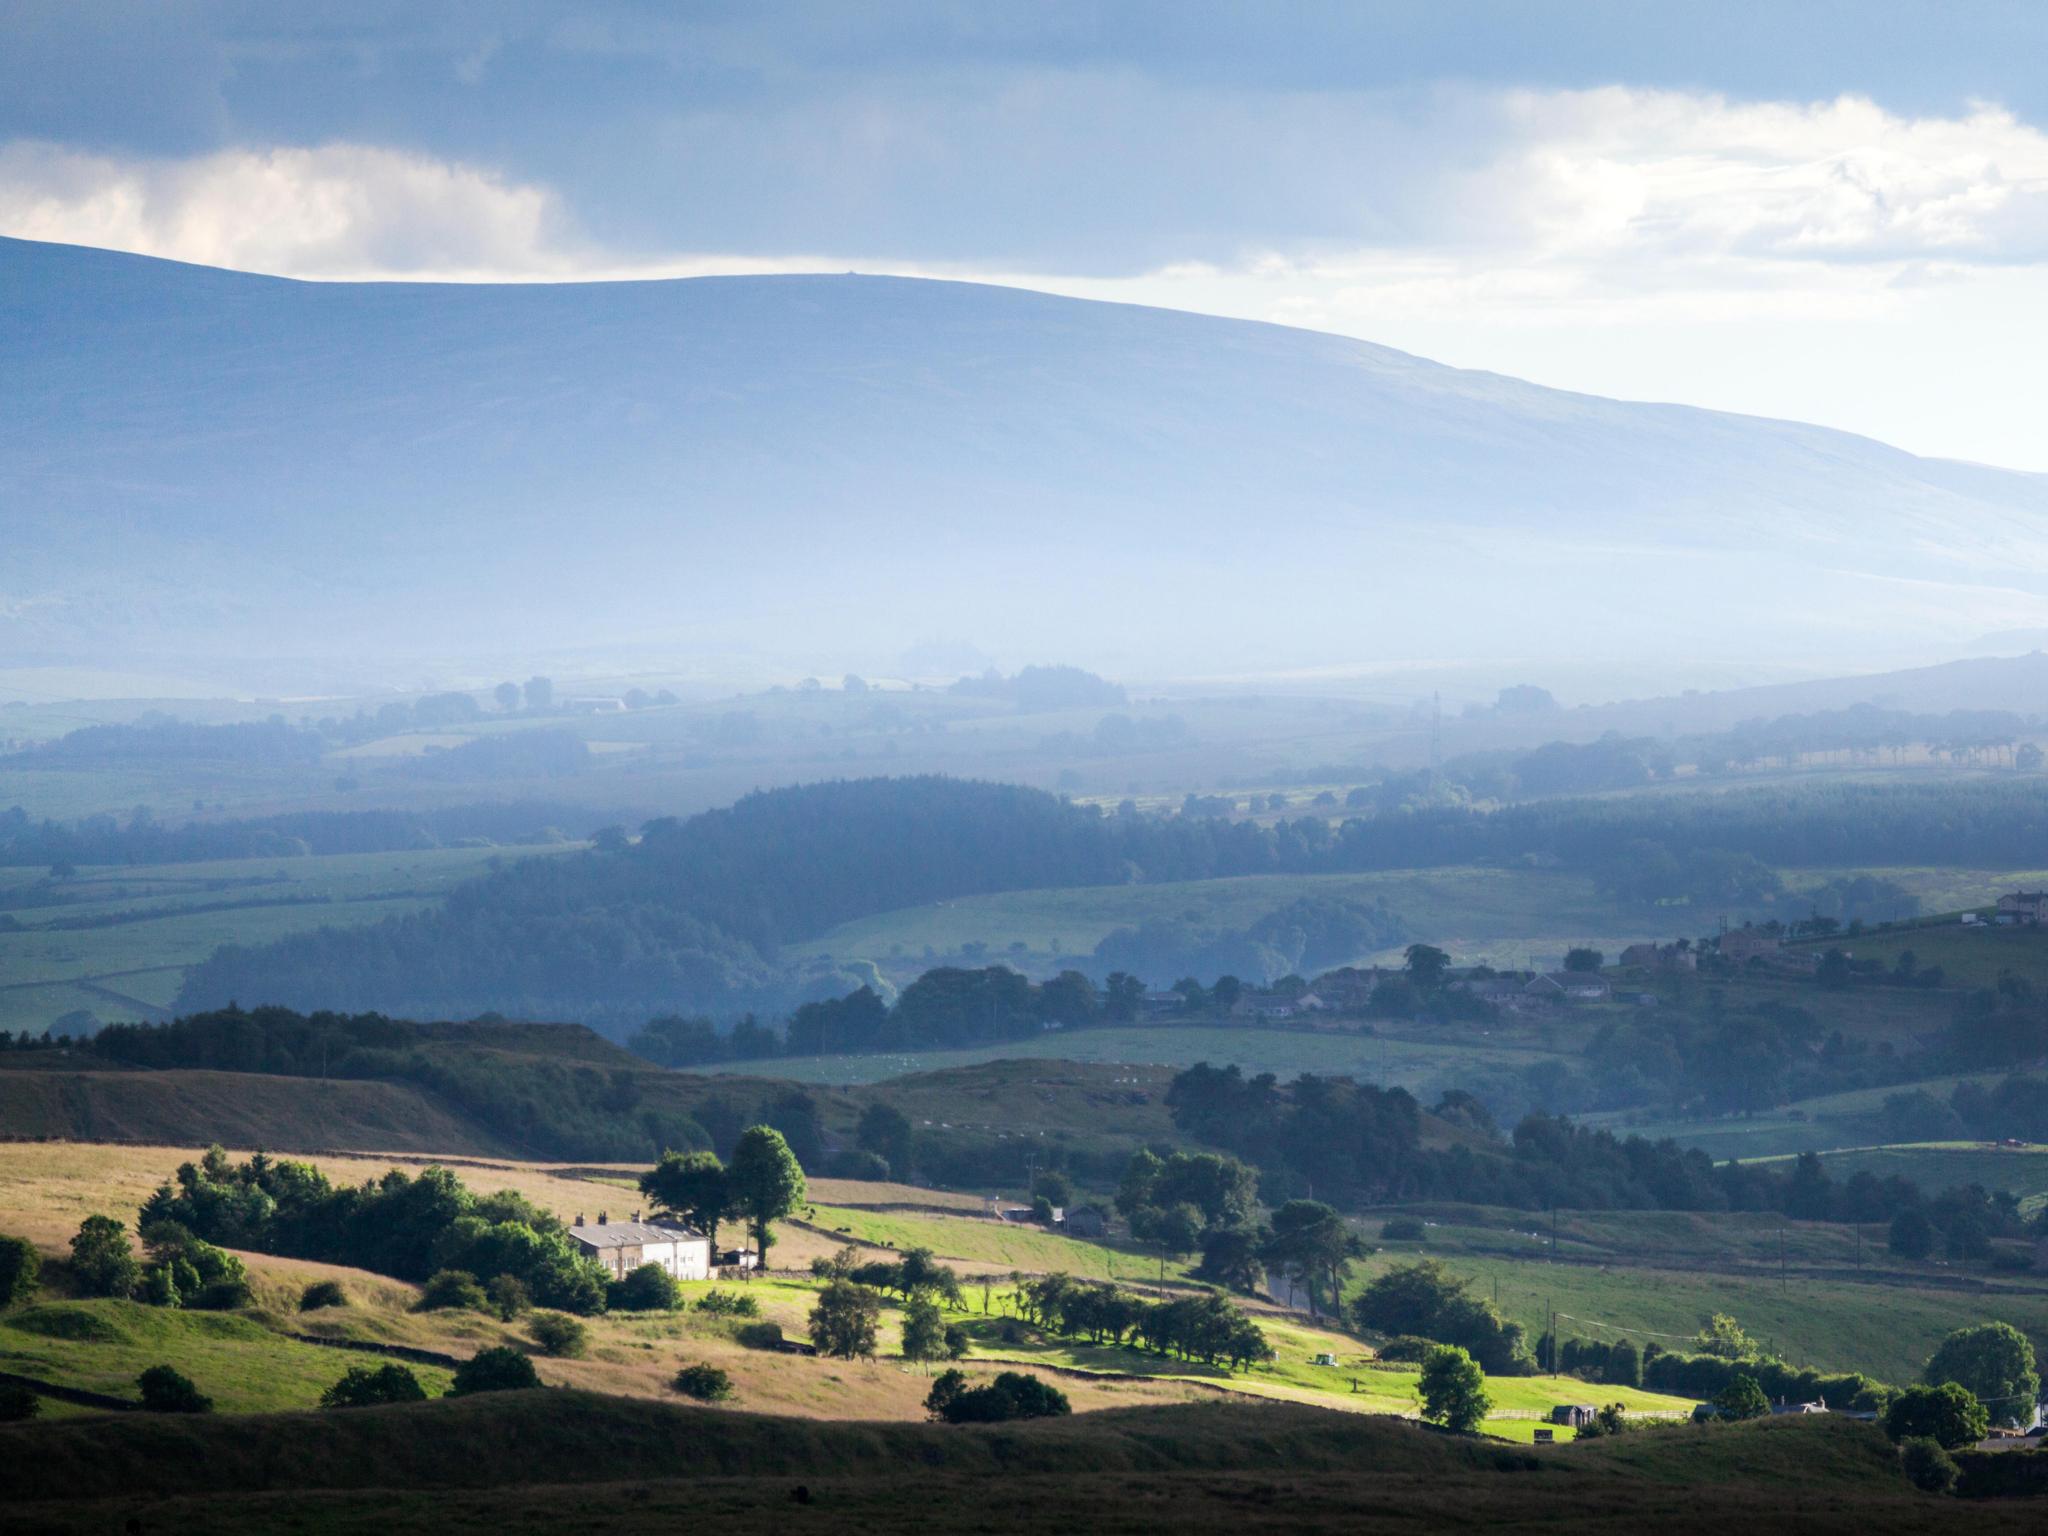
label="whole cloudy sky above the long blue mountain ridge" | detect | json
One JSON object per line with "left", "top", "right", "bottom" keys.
{"left": 12, "top": 0, "right": 2048, "bottom": 471}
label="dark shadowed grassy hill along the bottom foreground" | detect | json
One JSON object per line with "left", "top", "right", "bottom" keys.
{"left": 0, "top": 1392, "right": 2015, "bottom": 1536}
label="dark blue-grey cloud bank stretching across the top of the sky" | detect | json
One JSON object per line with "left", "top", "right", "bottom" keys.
{"left": 12, "top": 0, "right": 2048, "bottom": 272}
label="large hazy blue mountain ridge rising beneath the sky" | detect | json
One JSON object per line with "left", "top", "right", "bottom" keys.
{"left": 16, "top": 240, "right": 2048, "bottom": 676}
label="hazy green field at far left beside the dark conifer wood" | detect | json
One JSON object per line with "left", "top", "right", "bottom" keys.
{"left": 0, "top": 844, "right": 582, "bottom": 1032}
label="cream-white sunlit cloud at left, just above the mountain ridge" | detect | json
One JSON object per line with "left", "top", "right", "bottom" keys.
{"left": 0, "top": 143, "right": 602, "bottom": 279}
